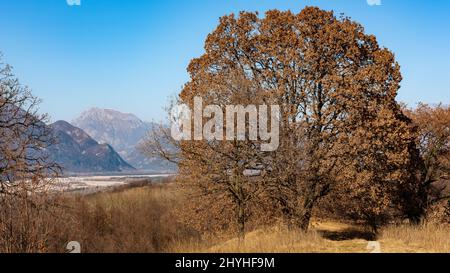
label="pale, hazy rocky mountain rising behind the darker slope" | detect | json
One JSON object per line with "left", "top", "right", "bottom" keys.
{"left": 72, "top": 108, "right": 174, "bottom": 171}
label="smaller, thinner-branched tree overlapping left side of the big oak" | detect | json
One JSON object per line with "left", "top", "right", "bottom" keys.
{"left": 142, "top": 74, "right": 270, "bottom": 241}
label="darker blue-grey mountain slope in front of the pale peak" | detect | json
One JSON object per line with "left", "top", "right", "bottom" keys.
{"left": 48, "top": 121, "right": 134, "bottom": 172}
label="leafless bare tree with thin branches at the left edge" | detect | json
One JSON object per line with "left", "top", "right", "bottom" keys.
{"left": 0, "top": 54, "right": 59, "bottom": 252}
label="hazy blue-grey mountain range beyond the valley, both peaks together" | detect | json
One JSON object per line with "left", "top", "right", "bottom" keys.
{"left": 47, "top": 108, "right": 176, "bottom": 173}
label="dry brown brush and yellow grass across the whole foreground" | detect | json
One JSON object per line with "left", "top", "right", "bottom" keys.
{"left": 14, "top": 181, "right": 450, "bottom": 253}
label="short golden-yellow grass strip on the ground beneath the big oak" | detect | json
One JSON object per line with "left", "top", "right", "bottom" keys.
{"left": 172, "top": 219, "right": 450, "bottom": 253}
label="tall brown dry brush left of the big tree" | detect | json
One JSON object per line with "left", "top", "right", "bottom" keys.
{"left": 51, "top": 184, "right": 199, "bottom": 253}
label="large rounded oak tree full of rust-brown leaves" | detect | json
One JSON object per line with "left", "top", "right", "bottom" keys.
{"left": 146, "top": 7, "right": 424, "bottom": 234}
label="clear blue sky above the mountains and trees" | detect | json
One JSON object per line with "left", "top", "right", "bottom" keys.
{"left": 0, "top": 0, "right": 450, "bottom": 121}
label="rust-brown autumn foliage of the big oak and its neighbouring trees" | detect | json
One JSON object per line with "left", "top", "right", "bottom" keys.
{"left": 143, "top": 7, "right": 450, "bottom": 238}
